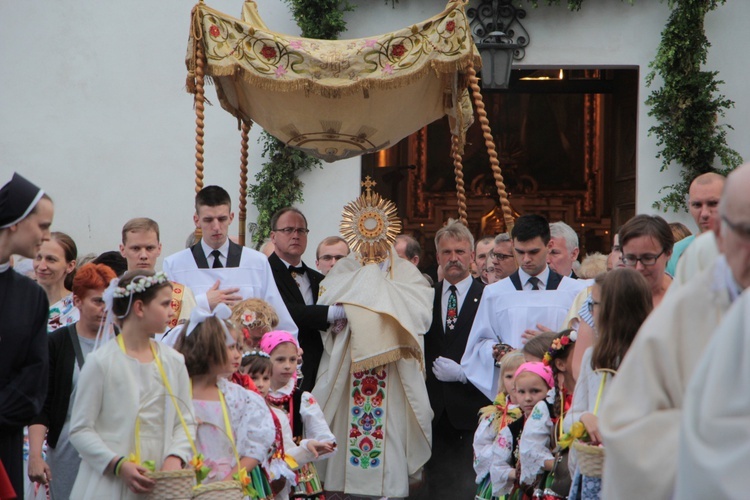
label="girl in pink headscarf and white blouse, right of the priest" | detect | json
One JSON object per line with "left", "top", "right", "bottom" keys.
{"left": 492, "top": 361, "right": 555, "bottom": 498}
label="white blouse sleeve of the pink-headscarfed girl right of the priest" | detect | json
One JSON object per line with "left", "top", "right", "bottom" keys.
{"left": 518, "top": 401, "right": 554, "bottom": 484}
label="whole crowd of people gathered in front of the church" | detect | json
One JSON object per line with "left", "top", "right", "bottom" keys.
{"left": 0, "top": 164, "right": 750, "bottom": 500}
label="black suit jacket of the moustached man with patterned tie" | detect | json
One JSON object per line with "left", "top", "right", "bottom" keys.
{"left": 424, "top": 280, "right": 490, "bottom": 430}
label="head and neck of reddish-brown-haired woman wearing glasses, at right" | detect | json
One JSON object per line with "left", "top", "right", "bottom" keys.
{"left": 618, "top": 215, "right": 674, "bottom": 307}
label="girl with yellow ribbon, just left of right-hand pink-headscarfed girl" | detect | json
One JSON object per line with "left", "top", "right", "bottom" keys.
{"left": 473, "top": 351, "right": 524, "bottom": 500}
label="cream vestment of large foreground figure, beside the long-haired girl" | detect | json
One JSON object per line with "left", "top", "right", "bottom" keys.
{"left": 599, "top": 256, "right": 732, "bottom": 499}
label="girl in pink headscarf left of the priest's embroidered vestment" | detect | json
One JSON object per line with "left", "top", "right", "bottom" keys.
{"left": 260, "top": 331, "right": 336, "bottom": 498}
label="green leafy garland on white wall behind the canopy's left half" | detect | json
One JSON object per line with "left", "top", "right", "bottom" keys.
{"left": 247, "top": 0, "right": 354, "bottom": 248}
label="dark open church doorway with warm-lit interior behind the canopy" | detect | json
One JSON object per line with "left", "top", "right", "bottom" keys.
{"left": 362, "top": 68, "right": 639, "bottom": 269}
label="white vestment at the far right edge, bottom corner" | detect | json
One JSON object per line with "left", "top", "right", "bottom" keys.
{"left": 674, "top": 293, "right": 750, "bottom": 498}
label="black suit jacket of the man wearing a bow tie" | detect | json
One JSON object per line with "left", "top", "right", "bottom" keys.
{"left": 268, "top": 253, "right": 328, "bottom": 391}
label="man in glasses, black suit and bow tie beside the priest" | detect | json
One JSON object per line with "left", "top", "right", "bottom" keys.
{"left": 268, "top": 207, "right": 344, "bottom": 406}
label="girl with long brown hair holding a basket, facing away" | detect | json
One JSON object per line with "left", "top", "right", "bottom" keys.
{"left": 565, "top": 268, "right": 653, "bottom": 500}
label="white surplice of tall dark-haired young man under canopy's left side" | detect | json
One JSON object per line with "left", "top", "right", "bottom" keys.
{"left": 164, "top": 243, "right": 297, "bottom": 337}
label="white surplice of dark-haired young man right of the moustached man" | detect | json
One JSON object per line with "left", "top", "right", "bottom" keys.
{"left": 461, "top": 276, "right": 590, "bottom": 400}
